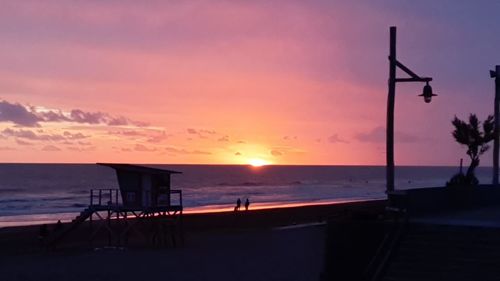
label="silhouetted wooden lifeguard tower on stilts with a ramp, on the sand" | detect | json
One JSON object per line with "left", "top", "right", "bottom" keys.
{"left": 48, "top": 163, "right": 183, "bottom": 246}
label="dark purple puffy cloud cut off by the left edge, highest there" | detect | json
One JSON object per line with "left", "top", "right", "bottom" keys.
{"left": 0, "top": 100, "right": 40, "bottom": 127}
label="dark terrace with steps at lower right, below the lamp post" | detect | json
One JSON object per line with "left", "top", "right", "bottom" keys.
{"left": 322, "top": 186, "right": 500, "bottom": 281}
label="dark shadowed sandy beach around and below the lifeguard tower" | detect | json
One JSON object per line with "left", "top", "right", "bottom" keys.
{"left": 0, "top": 201, "right": 384, "bottom": 280}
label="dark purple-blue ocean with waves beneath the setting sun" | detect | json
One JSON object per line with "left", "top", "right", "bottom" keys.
{"left": 0, "top": 164, "right": 492, "bottom": 227}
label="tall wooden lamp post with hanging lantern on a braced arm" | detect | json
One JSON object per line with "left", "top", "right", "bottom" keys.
{"left": 386, "top": 26, "right": 436, "bottom": 193}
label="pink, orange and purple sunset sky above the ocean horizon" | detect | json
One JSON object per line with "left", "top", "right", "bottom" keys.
{"left": 0, "top": 0, "right": 500, "bottom": 165}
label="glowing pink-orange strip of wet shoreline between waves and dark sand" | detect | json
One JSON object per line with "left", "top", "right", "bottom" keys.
{"left": 0, "top": 198, "right": 384, "bottom": 229}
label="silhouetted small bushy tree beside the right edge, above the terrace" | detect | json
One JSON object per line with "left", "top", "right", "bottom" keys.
{"left": 448, "top": 114, "right": 495, "bottom": 185}
